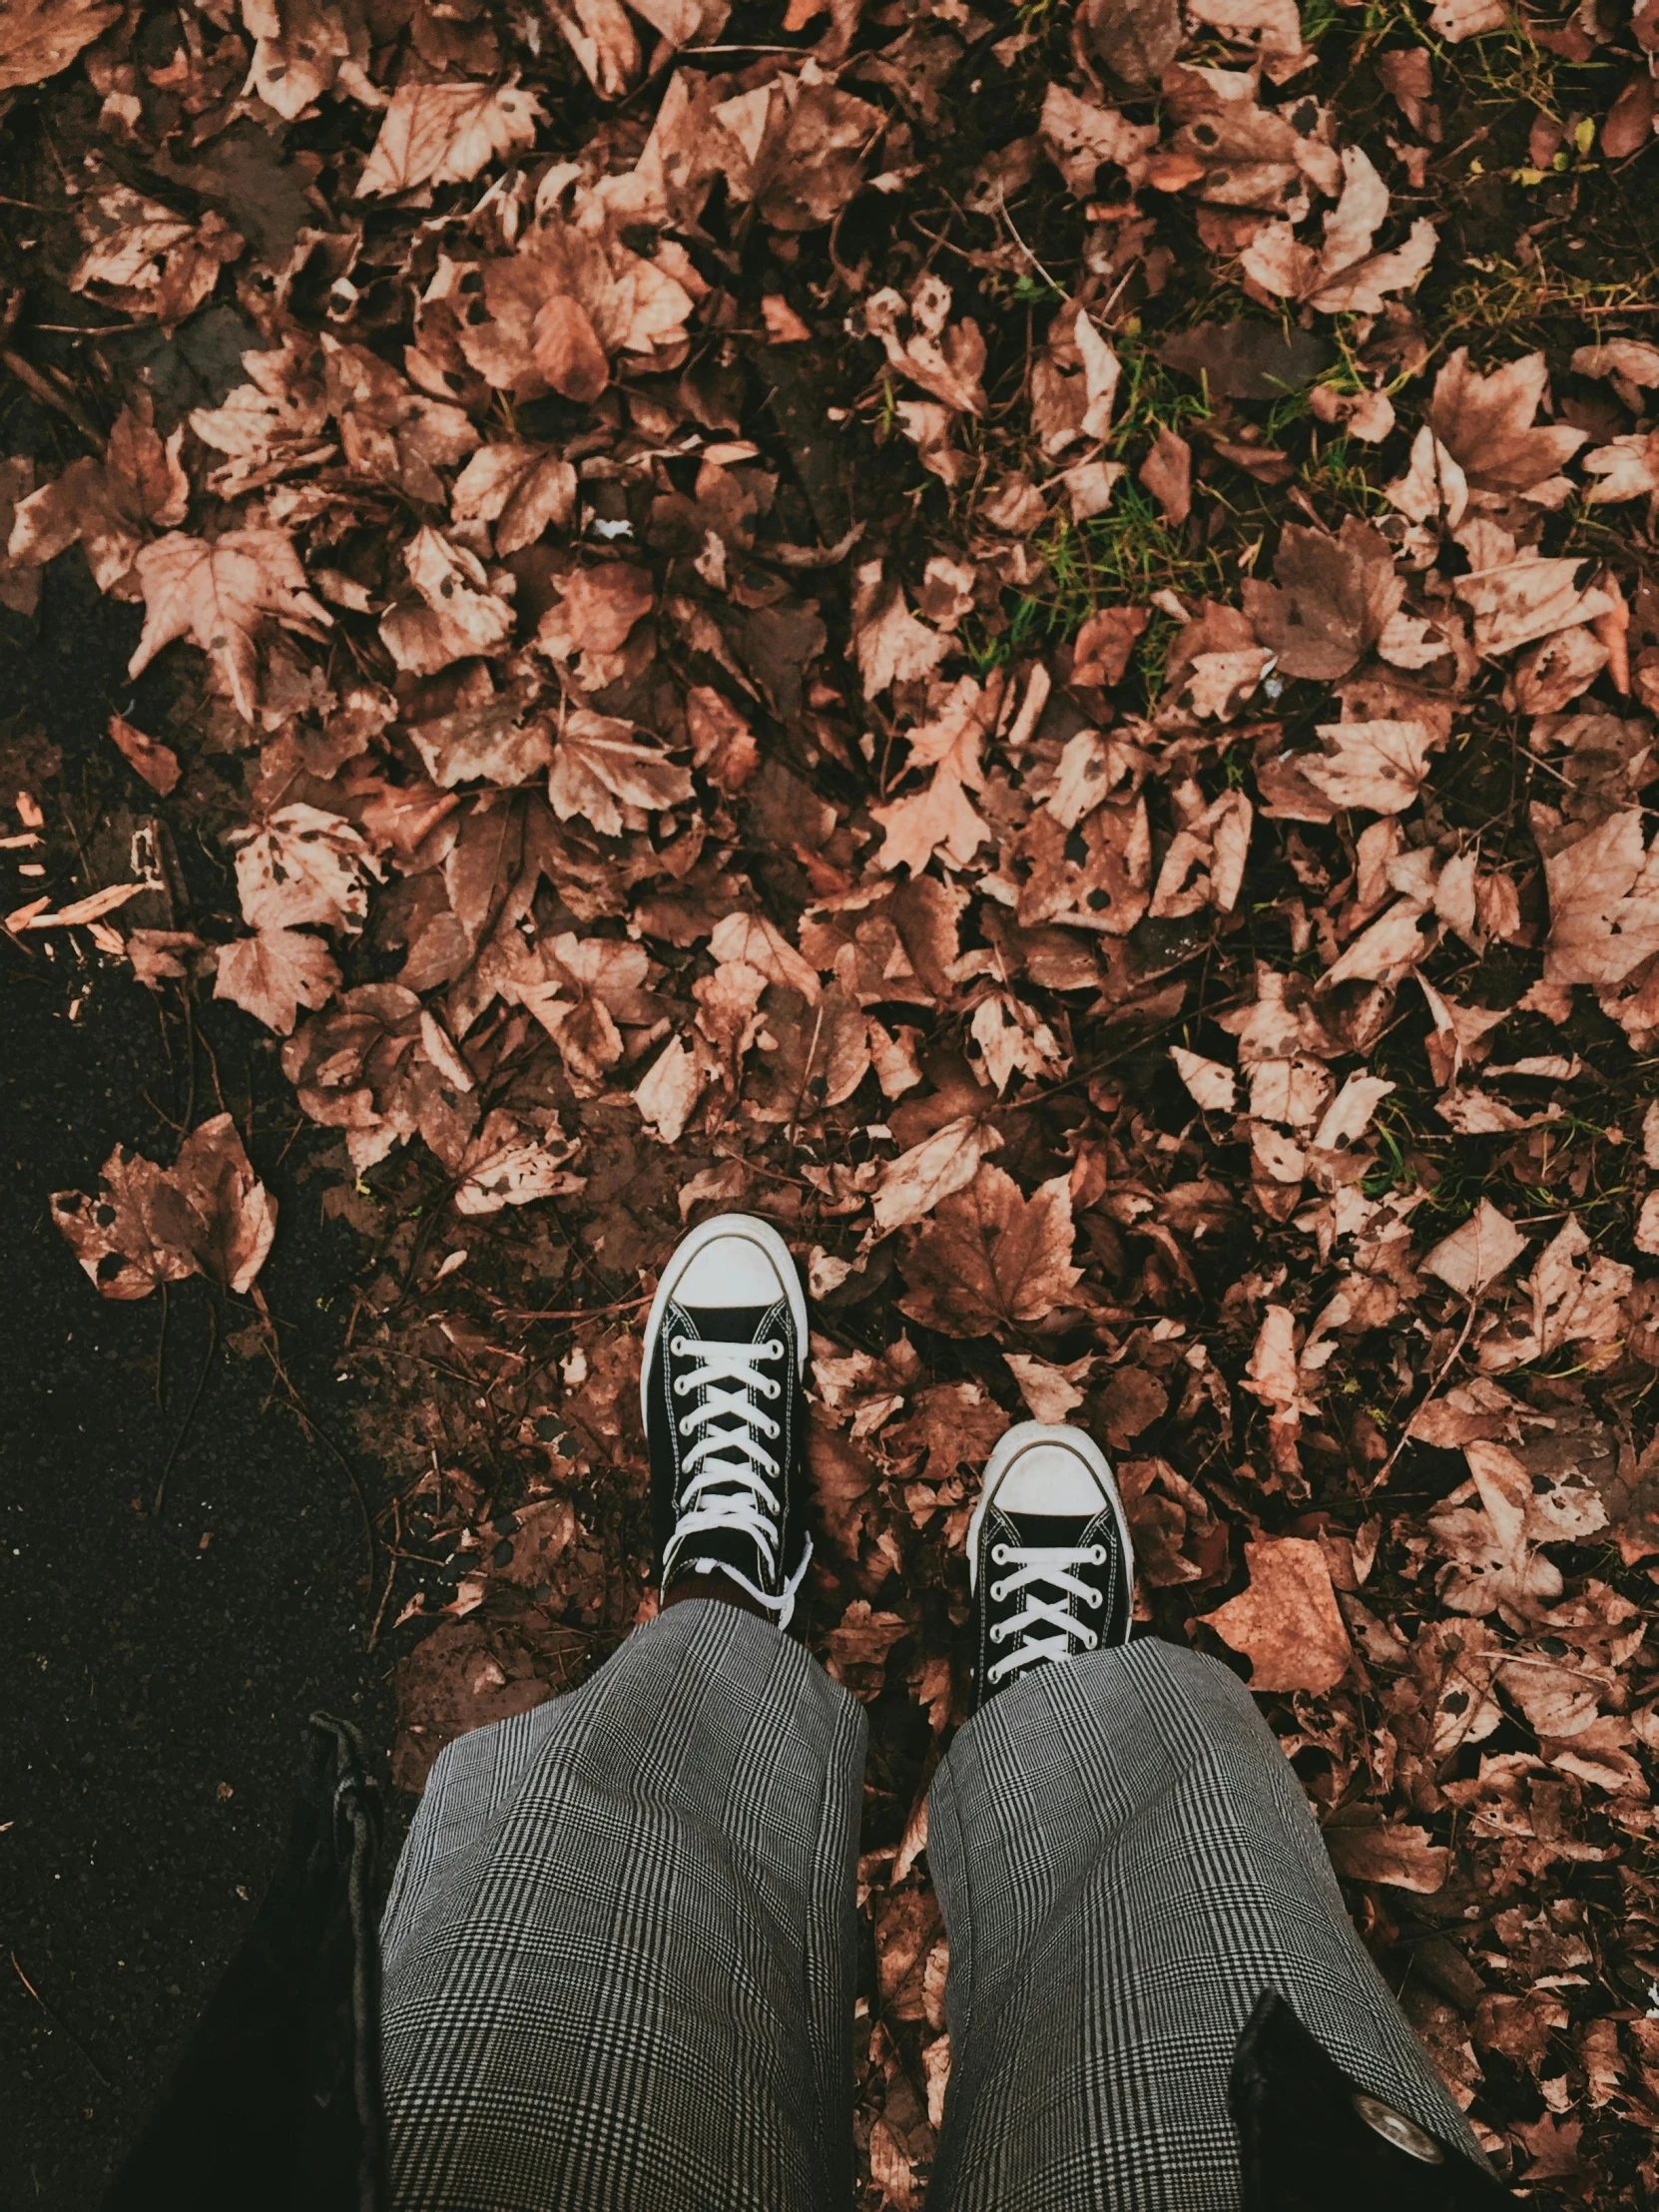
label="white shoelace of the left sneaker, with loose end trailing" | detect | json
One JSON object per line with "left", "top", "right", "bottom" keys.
{"left": 664, "top": 1336, "right": 812, "bottom": 1628}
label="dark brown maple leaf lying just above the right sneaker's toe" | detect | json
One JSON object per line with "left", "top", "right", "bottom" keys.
{"left": 898, "top": 1161, "right": 1082, "bottom": 1336}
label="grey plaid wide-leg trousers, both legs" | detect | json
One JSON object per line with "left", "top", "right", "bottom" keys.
{"left": 385, "top": 1601, "right": 1473, "bottom": 2212}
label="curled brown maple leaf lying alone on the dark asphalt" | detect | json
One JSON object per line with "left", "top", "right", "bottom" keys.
{"left": 51, "top": 1113, "right": 276, "bottom": 1299}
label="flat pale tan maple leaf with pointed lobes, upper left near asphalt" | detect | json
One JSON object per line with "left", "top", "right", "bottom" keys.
{"left": 126, "top": 529, "right": 334, "bottom": 721}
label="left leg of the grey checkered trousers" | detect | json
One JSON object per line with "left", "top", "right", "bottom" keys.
{"left": 382, "top": 1601, "right": 864, "bottom": 2212}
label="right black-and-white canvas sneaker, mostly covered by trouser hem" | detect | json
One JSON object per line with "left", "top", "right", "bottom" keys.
{"left": 969, "top": 1420, "right": 1135, "bottom": 1706}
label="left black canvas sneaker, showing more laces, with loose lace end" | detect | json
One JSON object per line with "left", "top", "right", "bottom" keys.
{"left": 639, "top": 1215, "right": 812, "bottom": 1628}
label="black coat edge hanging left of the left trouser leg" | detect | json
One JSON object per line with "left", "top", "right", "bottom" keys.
{"left": 104, "top": 1712, "right": 387, "bottom": 2212}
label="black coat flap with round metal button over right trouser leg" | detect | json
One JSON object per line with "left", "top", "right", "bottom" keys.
{"left": 1228, "top": 1988, "right": 1515, "bottom": 2212}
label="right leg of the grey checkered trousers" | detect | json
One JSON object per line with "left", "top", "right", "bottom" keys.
{"left": 929, "top": 1641, "right": 1466, "bottom": 2212}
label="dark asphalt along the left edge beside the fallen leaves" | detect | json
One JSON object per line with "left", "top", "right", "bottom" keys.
{"left": 0, "top": 553, "right": 391, "bottom": 2212}
